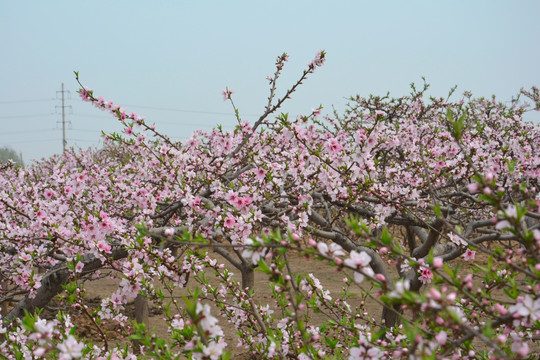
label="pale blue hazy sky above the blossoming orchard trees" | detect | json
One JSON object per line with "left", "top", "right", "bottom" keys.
{"left": 0, "top": 0, "right": 540, "bottom": 163}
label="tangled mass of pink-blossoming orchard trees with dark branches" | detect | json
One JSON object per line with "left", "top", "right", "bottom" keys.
{"left": 0, "top": 51, "right": 540, "bottom": 359}
